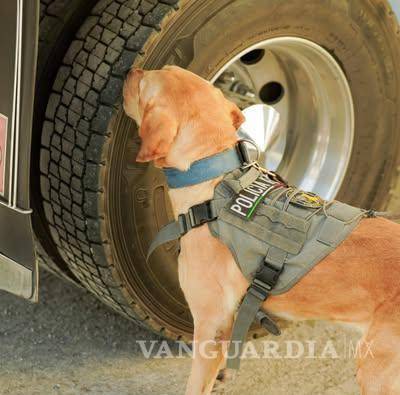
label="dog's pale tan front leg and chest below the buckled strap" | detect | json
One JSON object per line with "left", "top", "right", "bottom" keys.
{"left": 179, "top": 227, "right": 248, "bottom": 395}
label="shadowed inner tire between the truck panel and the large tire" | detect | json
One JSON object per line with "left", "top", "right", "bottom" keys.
{"left": 31, "top": 0, "right": 97, "bottom": 283}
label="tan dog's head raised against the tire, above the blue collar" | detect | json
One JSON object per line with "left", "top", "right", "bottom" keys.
{"left": 124, "top": 66, "right": 244, "bottom": 170}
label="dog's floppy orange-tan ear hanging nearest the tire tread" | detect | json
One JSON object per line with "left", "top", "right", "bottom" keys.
{"left": 136, "top": 103, "right": 178, "bottom": 162}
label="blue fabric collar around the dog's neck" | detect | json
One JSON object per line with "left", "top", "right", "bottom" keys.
{"left": 163, "top": 143, "right": 245, "bottom": 188}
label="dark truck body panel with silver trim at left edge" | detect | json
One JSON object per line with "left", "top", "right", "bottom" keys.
{"left": 0, "top": 0, "right": 39, "bottom": 300}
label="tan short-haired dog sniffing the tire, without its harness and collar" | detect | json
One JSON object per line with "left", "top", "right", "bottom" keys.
{"left": 123, "top": 66, "right": 400, "bottom": 395}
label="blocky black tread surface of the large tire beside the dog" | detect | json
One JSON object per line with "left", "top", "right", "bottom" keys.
{"left": 40, "top": 0, "right": 185, "bottom": 336}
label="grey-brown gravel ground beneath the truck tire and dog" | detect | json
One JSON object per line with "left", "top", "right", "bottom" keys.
{"left": 0, "top": 273, "right": 359, "bottom": 395}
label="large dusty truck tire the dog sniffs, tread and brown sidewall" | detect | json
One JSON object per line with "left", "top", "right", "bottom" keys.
{"left": 40, "top": 0, "right": 400, "bottom": 339}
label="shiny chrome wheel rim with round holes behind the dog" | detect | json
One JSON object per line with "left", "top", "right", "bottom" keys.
{"left": 212, "top": 37, "right": 354, "bottom": 199}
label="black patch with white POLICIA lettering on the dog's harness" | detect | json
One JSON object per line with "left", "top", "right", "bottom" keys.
{"left": 229, "top": 174, "right": 282, "bottom": 219}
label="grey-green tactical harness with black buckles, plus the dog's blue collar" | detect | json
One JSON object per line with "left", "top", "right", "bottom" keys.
{"left": 148, "top": 142, "right": 373, "bottom": 369}
